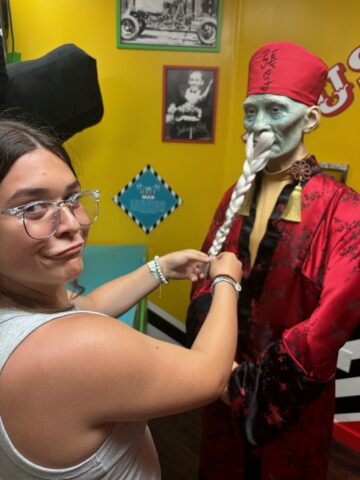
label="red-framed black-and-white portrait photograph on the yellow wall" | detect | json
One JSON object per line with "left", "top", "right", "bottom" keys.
{"left": 162, "top": 65, "right": 218, "bottom": 143}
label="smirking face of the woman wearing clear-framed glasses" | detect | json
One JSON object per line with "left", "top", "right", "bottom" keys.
{"left": 0, "top": 148, "right": 88, "bottom": 296}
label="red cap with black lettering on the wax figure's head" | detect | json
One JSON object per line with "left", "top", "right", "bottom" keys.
{"left": 247, "top": 42, "right": 328, "bottom": 105}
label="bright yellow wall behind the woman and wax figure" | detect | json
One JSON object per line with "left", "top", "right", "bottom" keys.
{"left": 11, "top": 0, "right": 360, "bottom": 321}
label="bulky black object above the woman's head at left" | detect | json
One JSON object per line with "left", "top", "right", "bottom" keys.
{"left": 1, "top": 44, "right": 104, "bottom": 141}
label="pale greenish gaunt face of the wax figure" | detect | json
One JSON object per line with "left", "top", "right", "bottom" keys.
{"left": 244, "top": 94, "right": 311, "bottom": 161}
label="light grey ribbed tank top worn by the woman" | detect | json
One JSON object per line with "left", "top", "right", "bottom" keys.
{"left": 0, "top": 309, "right": 161, "bottom": 480}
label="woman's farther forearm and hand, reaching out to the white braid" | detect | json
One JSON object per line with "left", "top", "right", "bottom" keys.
{"left": 70, "top": 249, "right": 209, "bottom": 317}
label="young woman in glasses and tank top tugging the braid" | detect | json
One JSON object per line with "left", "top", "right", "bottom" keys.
{"left": 0, "top": 120, "right": 241, "bottom": 480}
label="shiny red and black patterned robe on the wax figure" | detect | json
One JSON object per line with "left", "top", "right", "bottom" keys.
{"left": 187, "top": 158, "right": 360, "bottom": 480}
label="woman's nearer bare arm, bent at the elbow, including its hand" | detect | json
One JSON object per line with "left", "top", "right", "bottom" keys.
{"left": 23, "top": 253, "right": 241, "bottom": 425}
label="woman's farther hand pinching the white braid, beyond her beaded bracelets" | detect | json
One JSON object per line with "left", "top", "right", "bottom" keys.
{"left": 159, "top": 249, "right": 210, "bottom": 282}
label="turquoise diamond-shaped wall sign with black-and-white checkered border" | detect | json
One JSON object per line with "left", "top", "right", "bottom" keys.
{"left": 114, "top": 165, "right": 182, "bottom": 233}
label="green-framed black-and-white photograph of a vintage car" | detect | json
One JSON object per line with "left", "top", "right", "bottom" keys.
{"left": 116, "top": 0, "right": 222, "bottom": 52}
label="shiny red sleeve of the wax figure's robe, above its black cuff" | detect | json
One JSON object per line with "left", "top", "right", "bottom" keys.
{"left": 283, "top": 203, "right": 360, "bottom": 382}
